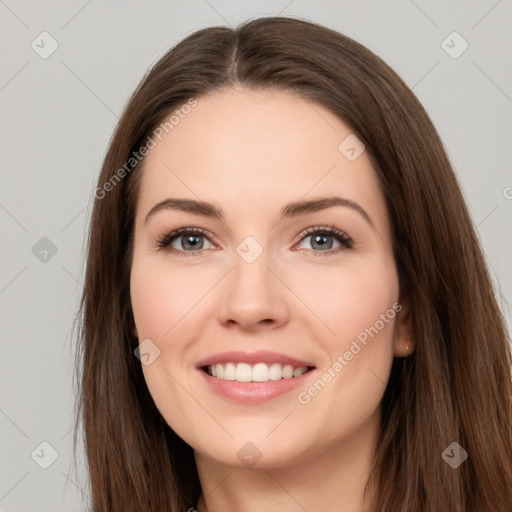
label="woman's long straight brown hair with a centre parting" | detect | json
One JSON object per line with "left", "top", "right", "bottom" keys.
{"left": 75, "top": 17, "right": 512, "bottom": 512}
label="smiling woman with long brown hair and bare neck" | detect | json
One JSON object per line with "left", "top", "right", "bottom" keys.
{"left": 75, "top": 18, "right": 512, "bottom": 512}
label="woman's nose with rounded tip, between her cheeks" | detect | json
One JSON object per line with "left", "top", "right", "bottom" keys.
{"left": 218, "top": 252, "right": 289, "bottom": 331}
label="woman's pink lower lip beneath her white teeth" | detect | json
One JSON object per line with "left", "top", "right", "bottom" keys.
{"left": 198, "top": 369, "right": 315, "bottom": 404}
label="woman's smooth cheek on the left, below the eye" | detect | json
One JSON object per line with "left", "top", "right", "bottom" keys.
{"left": 130, "top": 256, "right": 216, "bottom": 406}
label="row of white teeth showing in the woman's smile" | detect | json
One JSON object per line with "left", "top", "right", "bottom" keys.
{"left": 208, "top": 362, "right": 308, "bottom": 382}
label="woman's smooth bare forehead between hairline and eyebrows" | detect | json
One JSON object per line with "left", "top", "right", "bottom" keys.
{"left": 138, "top": 89, "right": 386, "bottom": 228}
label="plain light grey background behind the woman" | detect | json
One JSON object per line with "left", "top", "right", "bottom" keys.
{"left": 0, "top": 0, "right": 512, "bottom": 512}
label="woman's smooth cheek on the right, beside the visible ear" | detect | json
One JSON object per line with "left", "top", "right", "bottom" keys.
{"left": 290, "top": 258, "right": 400, "bottom": 408}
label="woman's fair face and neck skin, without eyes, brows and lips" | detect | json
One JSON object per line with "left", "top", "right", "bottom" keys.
{"left": 130, "top": 89, "right": 414, "bottom": 512}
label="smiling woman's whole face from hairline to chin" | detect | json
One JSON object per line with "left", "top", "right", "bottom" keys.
{"left": 130, "top": 89, "right": 411, "bottom": 467}
